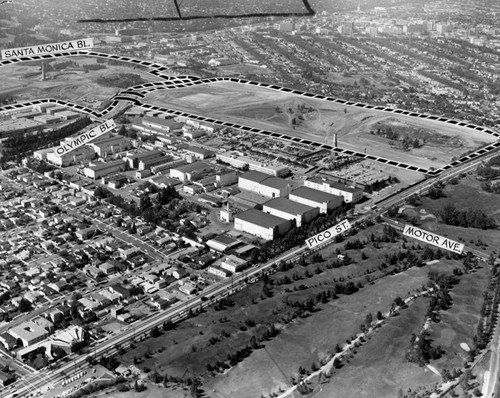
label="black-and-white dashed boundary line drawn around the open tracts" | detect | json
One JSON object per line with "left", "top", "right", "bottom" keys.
{"left": 0, "top": 50, "right": 500, "bottom": 177}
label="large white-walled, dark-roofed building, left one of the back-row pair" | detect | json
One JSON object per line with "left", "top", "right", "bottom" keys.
{"left": 238, "top": 171, "right": 290, "bottom": 198}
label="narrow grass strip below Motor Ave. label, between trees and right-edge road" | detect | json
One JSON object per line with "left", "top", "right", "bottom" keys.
{"left": 430, "top": 265, "right": 490, "bottom": 370}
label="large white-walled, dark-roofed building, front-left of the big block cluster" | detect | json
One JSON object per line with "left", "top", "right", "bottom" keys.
{"left": 234, "top": 209, "right": 292, "bottom": 240}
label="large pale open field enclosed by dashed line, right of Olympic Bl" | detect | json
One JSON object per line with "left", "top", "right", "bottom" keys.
{"left": 146, "top": 82, "right": 494, "bottom": 168}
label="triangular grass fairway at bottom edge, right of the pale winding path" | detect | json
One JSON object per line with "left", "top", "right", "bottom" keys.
{"left": 310, "top": 298, "right": 440, "bottom": 398}
